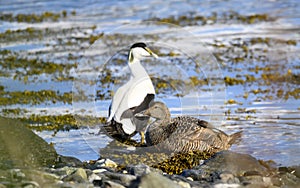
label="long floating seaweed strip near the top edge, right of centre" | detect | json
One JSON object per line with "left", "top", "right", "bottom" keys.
{"left": 146, "top": 11, "right": 275, "bottom": 26}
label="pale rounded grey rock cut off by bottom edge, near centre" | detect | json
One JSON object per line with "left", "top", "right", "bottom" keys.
{"left": 130, "top": 172, "right": 180, "bottom": 188}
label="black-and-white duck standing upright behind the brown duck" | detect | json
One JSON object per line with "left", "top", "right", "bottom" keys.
{"left": 104, "top": 42, "right": 157, "bottom": 142}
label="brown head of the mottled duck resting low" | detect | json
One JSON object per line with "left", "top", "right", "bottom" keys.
{"left": 143, "top": 102, "right": 170, "bottom": 120}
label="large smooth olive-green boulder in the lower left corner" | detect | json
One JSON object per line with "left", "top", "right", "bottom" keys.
{"left": 0, "top": 117, "right": 58, "bottom": 169}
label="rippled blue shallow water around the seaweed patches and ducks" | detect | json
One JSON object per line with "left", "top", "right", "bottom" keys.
{"left": 0, "top": 0, "right": 300, "bottom": 166}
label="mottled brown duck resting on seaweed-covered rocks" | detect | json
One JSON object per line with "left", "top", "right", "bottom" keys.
{"left": 143, "top": 102, "right": 242, "bottom": 153}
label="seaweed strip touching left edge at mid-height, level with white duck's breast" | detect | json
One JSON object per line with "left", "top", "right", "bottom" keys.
{"left": 0, "top": 90, "right": 72, "bottom": 106}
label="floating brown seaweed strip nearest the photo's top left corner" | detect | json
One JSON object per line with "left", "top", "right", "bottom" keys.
{"left": 0, "top": 10, "right": 76, "bottom": 23}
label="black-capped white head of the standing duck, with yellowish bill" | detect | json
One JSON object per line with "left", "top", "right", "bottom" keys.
{"left": 128, "top": 42, "right": 158, "bottom": 63}
